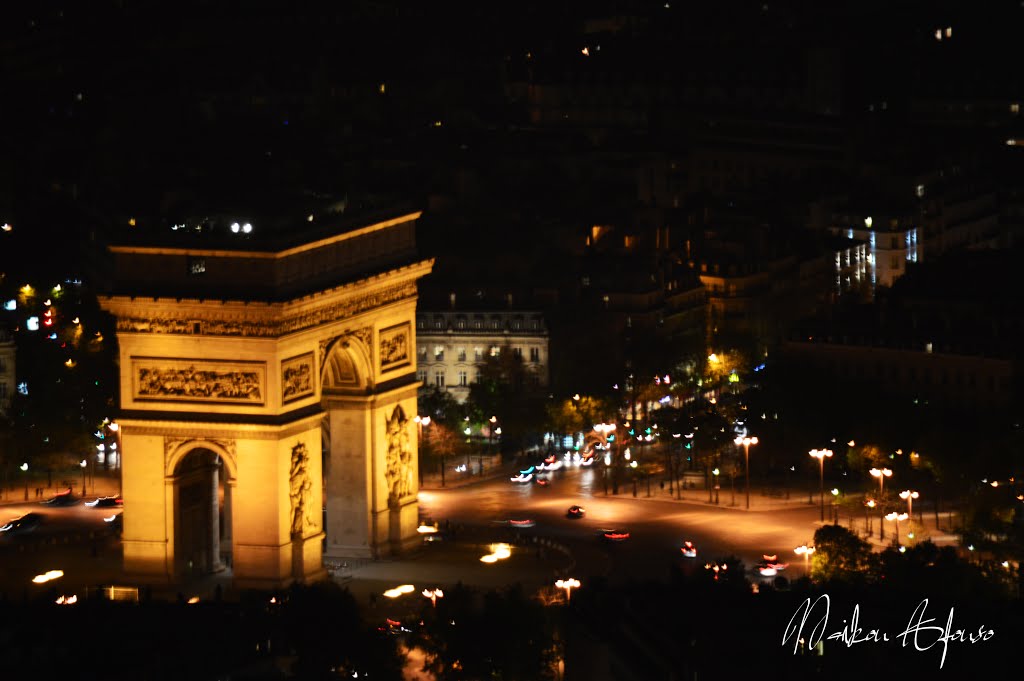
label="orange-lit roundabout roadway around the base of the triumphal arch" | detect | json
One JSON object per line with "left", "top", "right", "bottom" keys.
{"left": 0, "top": 458, "right": 954, "bottom": 602}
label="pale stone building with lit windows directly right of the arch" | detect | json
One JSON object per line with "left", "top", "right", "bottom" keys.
{"left": 416, "top": 307, "right": 550, "bottom": 402}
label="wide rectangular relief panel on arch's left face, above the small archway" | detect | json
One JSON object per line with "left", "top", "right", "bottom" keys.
{"left": 131, "top": 357, "right": 266, "bottom": 405}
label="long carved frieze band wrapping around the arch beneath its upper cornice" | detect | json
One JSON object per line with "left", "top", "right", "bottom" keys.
{"left": 117, "top": 283, "right": 416, "bottom": 337}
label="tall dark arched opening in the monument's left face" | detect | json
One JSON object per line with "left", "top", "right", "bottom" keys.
{"left": 173, "top": 448, "right": 233, "bottom": 579}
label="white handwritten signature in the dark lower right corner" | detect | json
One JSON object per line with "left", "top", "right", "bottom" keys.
{"left": 782, "top": 594, "right": 995, "bottom": 669}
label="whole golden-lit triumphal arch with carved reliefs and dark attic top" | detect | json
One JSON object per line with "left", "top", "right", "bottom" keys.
{"left": 100, "top": 213, "right": 433, "bottom": 587}
